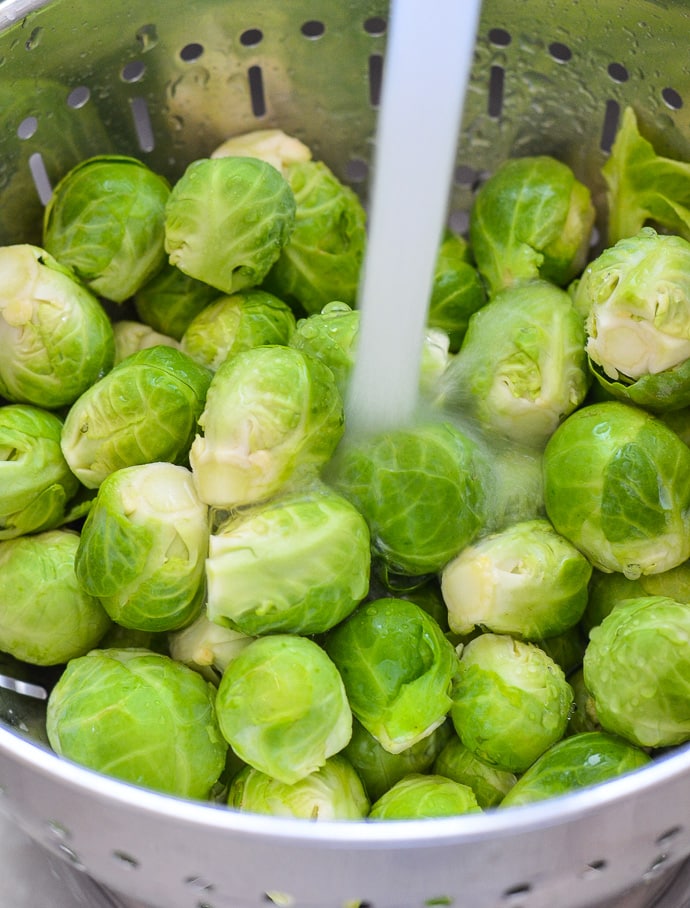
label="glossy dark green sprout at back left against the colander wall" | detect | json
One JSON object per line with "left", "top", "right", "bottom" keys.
{"left": 43, "top": 155, "right": 170, "bottom": 303}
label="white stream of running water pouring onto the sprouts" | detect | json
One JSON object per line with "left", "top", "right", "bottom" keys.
{"left": 347, "top": 0, "right": 481, "bottom": 432}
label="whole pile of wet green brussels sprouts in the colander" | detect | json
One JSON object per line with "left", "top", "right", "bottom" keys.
{"left": 0, "top": 110, "right": 690, "bottom": 820}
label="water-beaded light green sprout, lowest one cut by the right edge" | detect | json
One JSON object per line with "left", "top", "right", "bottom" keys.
{"left": 583, "top": 596, "right": 690, "bottom": 747}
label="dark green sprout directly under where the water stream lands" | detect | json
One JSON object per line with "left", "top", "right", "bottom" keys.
{"left": 327, "top": 422, "right": 486, "bottom": 576}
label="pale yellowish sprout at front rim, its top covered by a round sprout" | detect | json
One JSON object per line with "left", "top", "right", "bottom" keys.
{"left": 228, "top": 754, "right": 370, "bottom": 820}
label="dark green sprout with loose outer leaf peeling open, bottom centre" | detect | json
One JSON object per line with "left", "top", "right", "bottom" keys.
{"left": 323, "top": 598, "right": 458, "bottom": 754}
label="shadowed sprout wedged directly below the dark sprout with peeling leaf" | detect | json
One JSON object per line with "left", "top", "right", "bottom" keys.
{"left": 342, "top": 719, "right": 452, "bottom": 801}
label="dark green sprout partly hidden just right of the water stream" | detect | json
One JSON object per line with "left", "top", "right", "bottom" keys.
{"left": 427, "top": 232, "right": 486, "bottom": 353}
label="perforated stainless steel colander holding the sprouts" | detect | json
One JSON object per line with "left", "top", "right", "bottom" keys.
{"left": 0, "top": 0, "right": 690, "bottom": 908}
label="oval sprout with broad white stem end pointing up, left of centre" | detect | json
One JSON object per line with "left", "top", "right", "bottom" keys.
{"left": 75, "top": 463, "right": 209, "bottom": 632}
